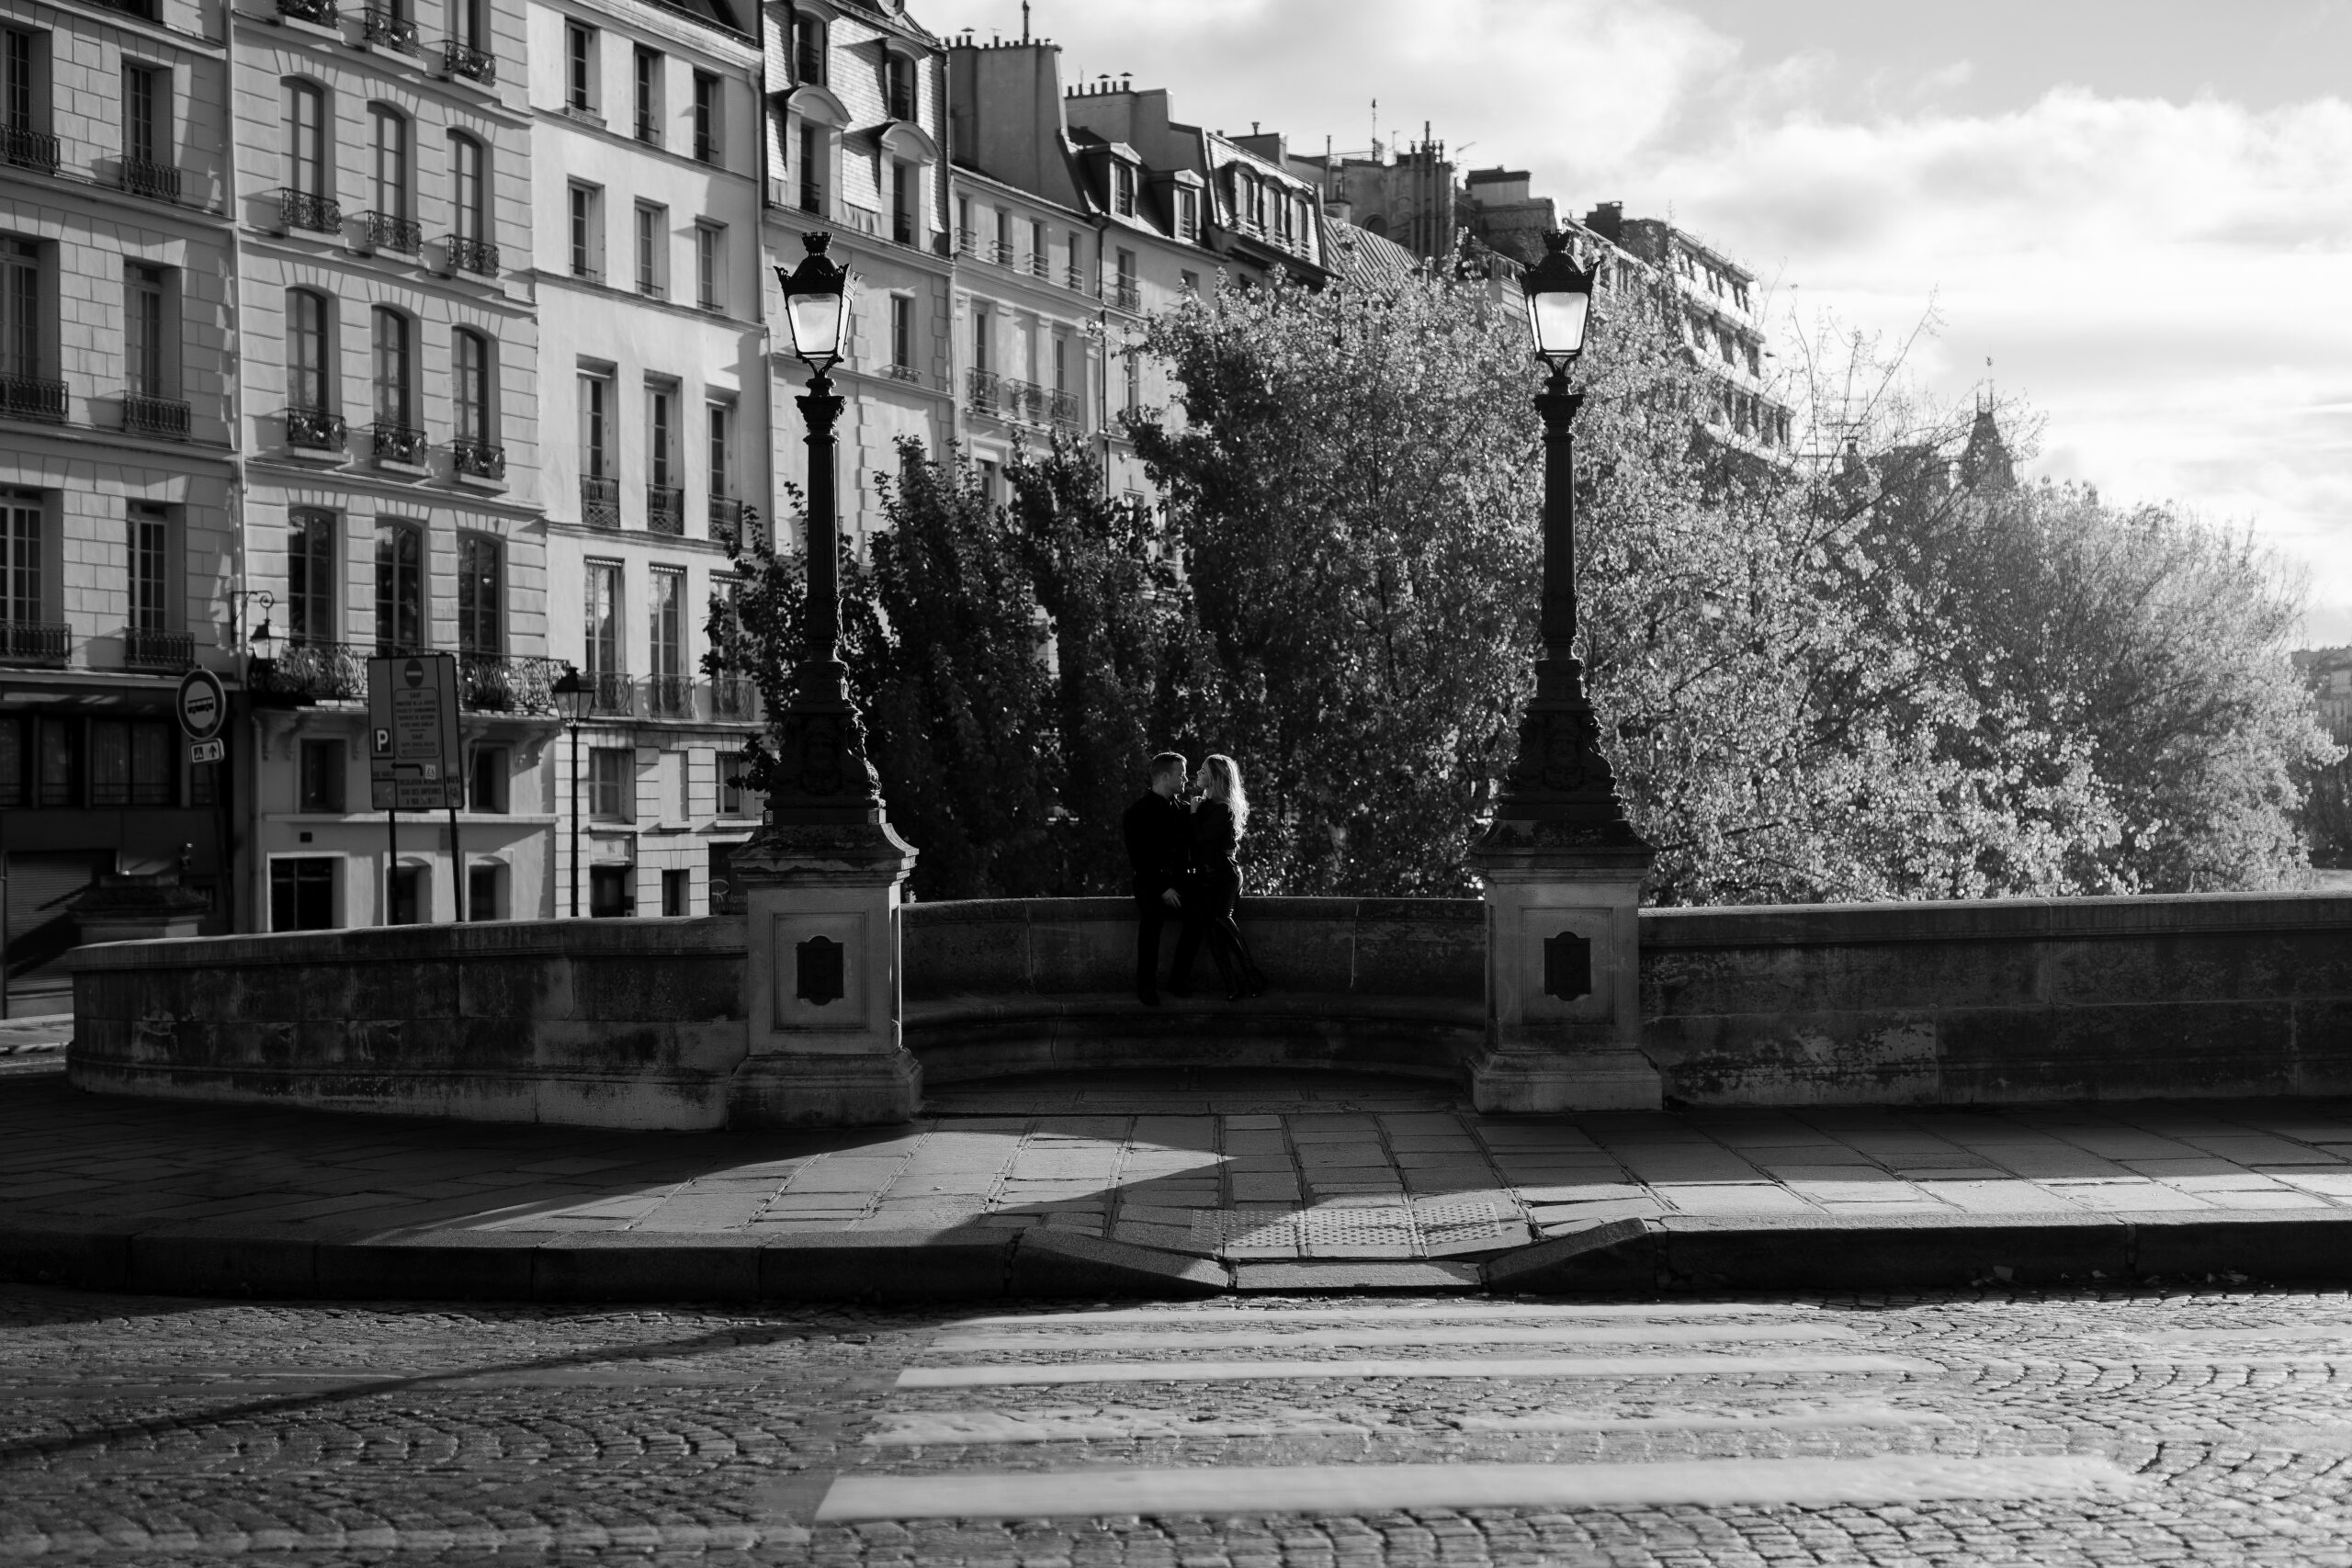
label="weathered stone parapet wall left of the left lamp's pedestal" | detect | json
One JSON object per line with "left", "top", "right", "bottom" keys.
{"left": 68, "top": 919, "right": 743, "bottom": 1128}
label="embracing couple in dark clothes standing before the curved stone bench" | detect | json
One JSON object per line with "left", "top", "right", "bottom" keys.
{"left": 1125, "top": 752, "right": 1265, "bottom": 1006}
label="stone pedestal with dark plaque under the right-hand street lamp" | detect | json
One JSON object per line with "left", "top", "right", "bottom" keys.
{"left": 1470, "top": 820, "right": 1660, "bottom": 1112}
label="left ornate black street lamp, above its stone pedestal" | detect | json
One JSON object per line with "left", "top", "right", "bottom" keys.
{"left": 769, "top": 231, "right": 882, "bottom": 828}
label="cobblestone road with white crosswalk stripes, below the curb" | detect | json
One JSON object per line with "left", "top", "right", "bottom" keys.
{"left": 0, "top": 1288, "right": 2352, "bottom": 1568}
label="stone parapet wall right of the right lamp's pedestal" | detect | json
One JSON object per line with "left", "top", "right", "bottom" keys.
{"left": 1642, "top": 894, "right": 2352, "bottom": 1105}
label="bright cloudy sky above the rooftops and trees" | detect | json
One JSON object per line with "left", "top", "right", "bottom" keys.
{"left": 910, "top": 0, "right": 2352, "bottom": 644}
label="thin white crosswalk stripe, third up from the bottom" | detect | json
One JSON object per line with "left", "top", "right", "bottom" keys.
{"left": 899, "top": 1354, "right": 1943, "bottom": 1389}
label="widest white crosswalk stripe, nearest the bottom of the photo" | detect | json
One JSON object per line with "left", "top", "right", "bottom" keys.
{"left": 816, "top": 1455, "right": 2145, "bottom": 1523}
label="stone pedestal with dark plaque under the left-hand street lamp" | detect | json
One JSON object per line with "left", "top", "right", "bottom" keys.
{"left": 727, "top": 813, "right": 922, "bottom": 1126}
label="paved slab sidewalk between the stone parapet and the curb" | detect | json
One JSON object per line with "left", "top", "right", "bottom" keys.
{"left": 0, "top": 1055, "right": 2352, "bottom": 1260}
